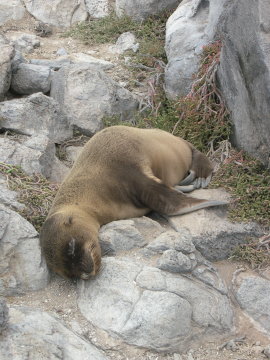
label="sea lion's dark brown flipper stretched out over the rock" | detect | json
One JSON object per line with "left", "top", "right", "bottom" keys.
{"left": 138, "top": 176, "right": 228, "bottom": 216}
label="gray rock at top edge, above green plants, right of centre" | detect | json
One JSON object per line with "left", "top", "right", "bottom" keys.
{"left": 115, "top": 0, "right": 181, "bottom": 21}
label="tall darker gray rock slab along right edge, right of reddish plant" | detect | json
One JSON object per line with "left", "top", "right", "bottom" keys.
{"left": 218, "top": 0, "right": 270, "bottom": 166}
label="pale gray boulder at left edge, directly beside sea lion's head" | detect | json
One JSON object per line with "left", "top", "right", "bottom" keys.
{"left": 0, "top": 205, "right": 49, "bottom": 296}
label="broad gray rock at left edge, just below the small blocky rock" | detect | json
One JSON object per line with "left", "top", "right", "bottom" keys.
{"left": 0, "top": 93, "right": 72, "bottom": 143}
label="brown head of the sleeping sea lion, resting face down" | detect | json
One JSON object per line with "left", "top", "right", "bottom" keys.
{"left": 40, "top": 211, "right": 101, "bottom": 280}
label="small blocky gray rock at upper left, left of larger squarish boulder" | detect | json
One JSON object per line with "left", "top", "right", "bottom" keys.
{"left": 11, "top": 63, "right": 51, "bottom": 95}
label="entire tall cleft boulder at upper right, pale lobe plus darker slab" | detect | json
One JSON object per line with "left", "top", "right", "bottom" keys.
{"left": 165, "top": 0, "right": 270, "bottom": 166}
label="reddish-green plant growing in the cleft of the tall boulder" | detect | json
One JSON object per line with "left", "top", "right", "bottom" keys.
{"left": 173, "top": 41, "right": 231, "bottom": 152}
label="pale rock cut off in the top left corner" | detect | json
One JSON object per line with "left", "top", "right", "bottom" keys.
{"left": 0, "top": 0, "right": 25, "bottom": 25}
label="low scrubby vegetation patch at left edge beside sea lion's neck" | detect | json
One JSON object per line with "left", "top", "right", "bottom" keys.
{"left": 0, "top": 162, "right": 59, "bottom": 231}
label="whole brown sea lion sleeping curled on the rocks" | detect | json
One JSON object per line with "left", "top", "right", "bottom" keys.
{"left": 40, "top": 126, "right": 225, "bottom": 280}
